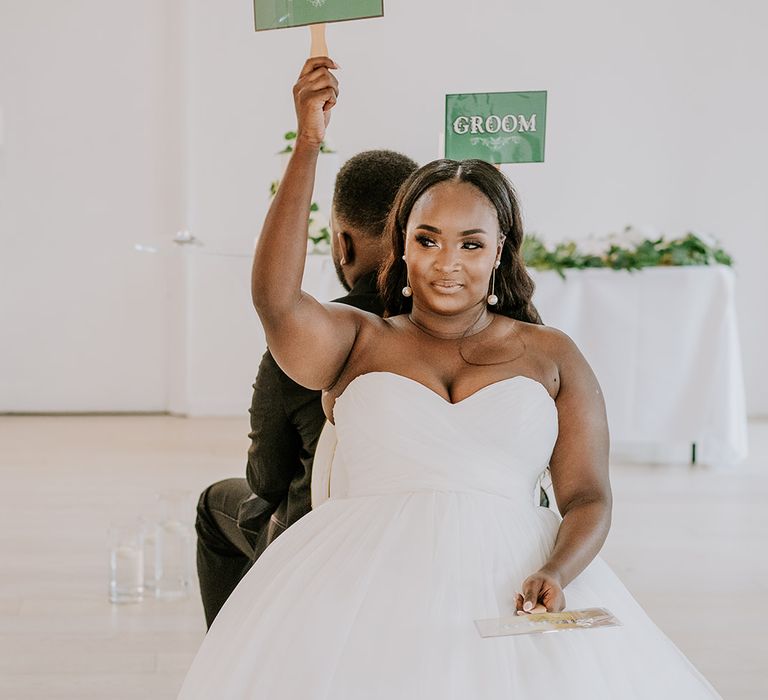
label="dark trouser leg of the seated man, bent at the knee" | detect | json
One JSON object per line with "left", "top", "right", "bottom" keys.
{"left": 195, "top": 479, "right": 256, "bottom": 627}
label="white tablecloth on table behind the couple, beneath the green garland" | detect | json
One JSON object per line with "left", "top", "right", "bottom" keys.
{"left": 304, "top": 256, "right": 747, "bottom": 466}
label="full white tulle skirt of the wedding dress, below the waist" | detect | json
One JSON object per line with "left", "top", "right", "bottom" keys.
{"left": 179, "top": 491, "right": 719, "bottom": 700}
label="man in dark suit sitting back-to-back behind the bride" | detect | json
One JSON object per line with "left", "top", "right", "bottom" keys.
{"left": 195, "top": 151, "right": 418, "bottom": 627}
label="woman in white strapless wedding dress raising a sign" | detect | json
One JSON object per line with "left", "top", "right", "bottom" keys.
{"left": 180, "top": 58, "right": 718, "bottom": 700}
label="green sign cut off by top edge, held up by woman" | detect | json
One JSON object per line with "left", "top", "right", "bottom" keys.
{"left": 253, "top": 0, "right": 384, "bottom": 32}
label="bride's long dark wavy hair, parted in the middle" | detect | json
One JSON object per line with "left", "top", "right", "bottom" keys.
{"left": 379, "top": 160, "right": 542, "bottom": 324}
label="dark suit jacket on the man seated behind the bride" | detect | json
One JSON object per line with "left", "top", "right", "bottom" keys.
{"left": 238, "top": 274, "right": 384, "bottom": 561}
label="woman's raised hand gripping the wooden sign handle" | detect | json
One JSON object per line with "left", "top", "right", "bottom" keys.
{"left": 293, "top": 56, "right": 339, "bottom": 148}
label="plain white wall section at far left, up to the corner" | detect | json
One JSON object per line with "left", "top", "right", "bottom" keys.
{"left": 0, "top": 0, "right": 184, "bottom": 411}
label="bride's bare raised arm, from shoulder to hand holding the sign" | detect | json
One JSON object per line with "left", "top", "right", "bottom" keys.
{"left": 251, "top": 57, "right": 361, "bottom": 389}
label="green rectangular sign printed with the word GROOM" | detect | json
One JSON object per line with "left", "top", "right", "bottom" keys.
{"left": 445, "top": 90, "right": 547, "bottom": 164}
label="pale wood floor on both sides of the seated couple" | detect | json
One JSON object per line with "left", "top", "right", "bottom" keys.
{"left": 0, "top": 417, "right": 768, "bottom": 700}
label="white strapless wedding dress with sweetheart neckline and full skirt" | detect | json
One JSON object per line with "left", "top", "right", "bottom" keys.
{"left": 180, "top": 372, "right": 718, "bottom": 700}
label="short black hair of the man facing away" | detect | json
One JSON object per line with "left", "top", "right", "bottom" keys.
{"left": 333, "top": 150, "right": 419, "bottom": 236}
